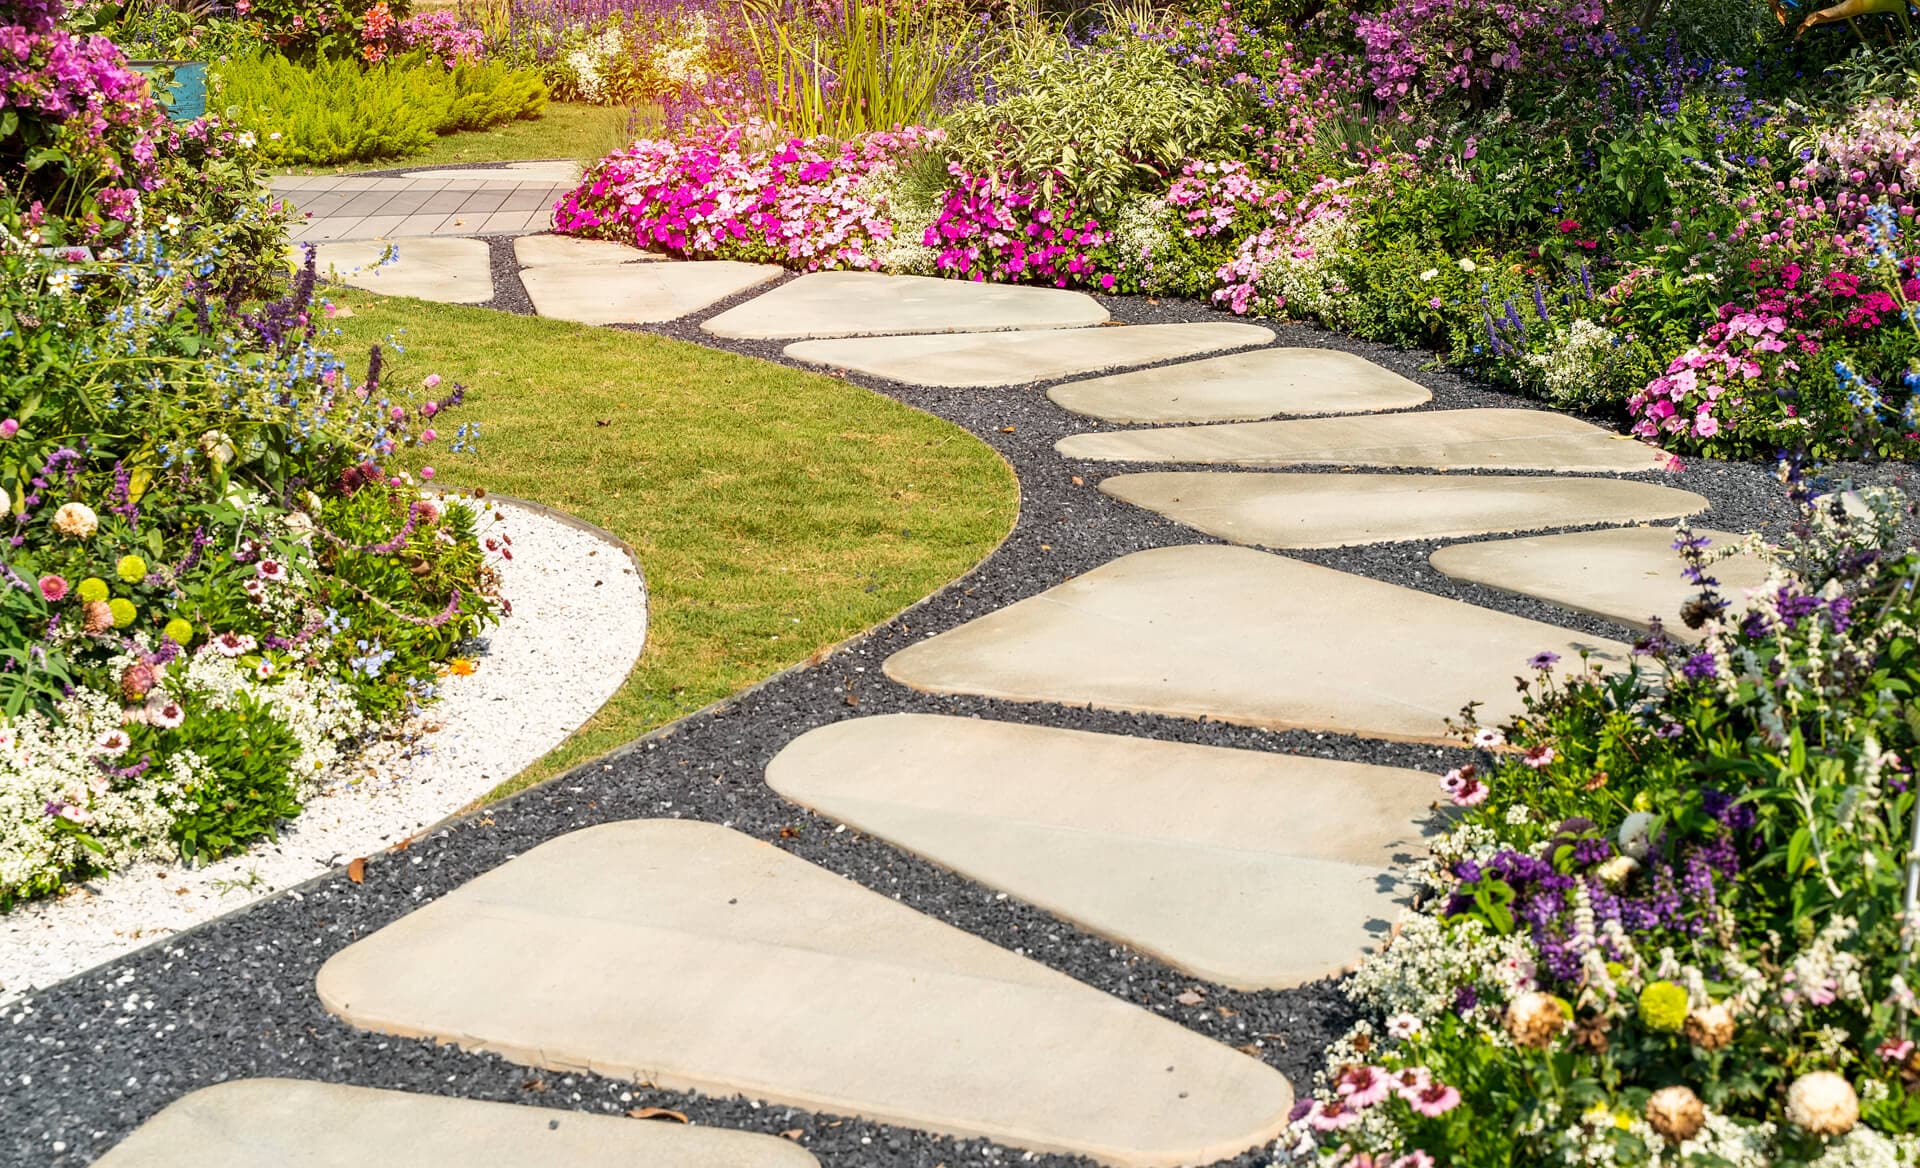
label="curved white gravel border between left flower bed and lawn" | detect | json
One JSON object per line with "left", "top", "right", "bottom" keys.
{"left": 0, "top": 498, "right": 647, "bottom": 1003}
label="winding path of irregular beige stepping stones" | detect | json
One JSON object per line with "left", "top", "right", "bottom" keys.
{"left": 78, "top": 223, "right": 1758, "bottom": 1168}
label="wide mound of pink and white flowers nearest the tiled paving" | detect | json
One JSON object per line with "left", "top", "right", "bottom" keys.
{"left": 555, "top": 127, "right": 937, "bottom": 271}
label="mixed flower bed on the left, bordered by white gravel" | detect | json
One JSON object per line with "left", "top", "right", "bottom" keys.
{"left": 0, "top": 6, "right": 497, "bottom": 909}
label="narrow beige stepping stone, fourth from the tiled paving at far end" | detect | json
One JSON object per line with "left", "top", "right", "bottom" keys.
{"left": 787, "top": 323, "right": 1273, "bottom": 388}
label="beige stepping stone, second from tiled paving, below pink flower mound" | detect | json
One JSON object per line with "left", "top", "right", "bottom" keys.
{"left": 520, "top": 259, "right": 781, "bottom": 325}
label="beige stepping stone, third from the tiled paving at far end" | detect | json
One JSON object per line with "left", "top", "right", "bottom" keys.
{"left": 701, "top": 271, "right": 1108, "bottom": 340}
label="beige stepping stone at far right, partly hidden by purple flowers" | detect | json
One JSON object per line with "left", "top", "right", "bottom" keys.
{"left": 1432, "top": 526, "right": 1766, "bottom": 640}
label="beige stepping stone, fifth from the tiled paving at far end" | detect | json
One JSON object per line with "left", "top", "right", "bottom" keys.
{"left": 1046, "top": 350, "right": 1432, "bottom": 423}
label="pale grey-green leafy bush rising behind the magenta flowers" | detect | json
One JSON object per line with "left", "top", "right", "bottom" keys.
{"left": 945, "top": 35, "right": 1233, "bottom": 215}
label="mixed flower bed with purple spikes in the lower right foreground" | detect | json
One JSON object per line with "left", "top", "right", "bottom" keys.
{"left": 1288, "top": 494, "right": 1920, "bottom": 1166}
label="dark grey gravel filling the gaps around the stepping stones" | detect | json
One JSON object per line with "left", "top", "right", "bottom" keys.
{"left": 0, "top": 265, "right": 1843, "bottom": 1168}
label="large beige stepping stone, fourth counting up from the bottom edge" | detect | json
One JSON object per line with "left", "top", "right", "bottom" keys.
{"left": 885, "top": 546, "right": 1630, "bottom": 742}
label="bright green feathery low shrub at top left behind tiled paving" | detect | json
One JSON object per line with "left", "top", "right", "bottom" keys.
{"left": 211, "top": 54, "right": 547, "bottom": 165}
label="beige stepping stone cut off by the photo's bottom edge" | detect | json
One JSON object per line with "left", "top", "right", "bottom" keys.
{"left": 96, "top": 1080, "right": 820, "bottom": 1168}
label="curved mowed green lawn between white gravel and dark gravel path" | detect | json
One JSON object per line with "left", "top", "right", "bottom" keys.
{"left": 332, "top": 290, "right": 1020, "bottom": 797}
